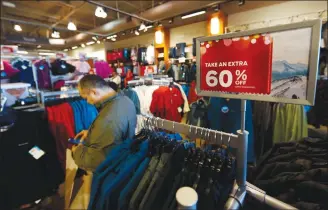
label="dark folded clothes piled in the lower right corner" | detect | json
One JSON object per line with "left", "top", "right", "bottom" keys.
{"left": 253, "top": 137, "right": 328, "bottom": 210}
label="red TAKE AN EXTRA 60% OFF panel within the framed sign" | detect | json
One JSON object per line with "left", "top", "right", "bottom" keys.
{"left": 200, "top": 35, "right": 273, "bottom": 94}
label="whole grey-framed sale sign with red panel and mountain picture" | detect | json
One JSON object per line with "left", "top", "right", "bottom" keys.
{"left": 196, "top": 20, "right": 321, "bottom": 105}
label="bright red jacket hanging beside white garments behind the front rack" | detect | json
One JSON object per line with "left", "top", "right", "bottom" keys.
{"left": 150, "top": 87, "right": 184, "bottom": 122}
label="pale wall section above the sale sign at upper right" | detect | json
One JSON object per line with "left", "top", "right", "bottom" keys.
{"left": 228, "top": 1, "right": 327, "bottom": 27}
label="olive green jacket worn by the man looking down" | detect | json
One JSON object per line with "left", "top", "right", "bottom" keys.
{"left": 73, "top": 93, "right": 137, "bottom": 171}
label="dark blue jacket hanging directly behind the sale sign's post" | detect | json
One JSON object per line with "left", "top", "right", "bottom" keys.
{"left": 208, "top": 98, "right": 255, "bottom": 162}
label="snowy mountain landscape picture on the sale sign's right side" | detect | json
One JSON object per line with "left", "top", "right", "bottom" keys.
{"left": 270, "top": 28, "right": 312, "bottom": 99}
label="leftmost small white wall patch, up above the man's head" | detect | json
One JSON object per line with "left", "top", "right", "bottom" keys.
{"left": 67, "top": 43, "right": 106, "bottom": 60}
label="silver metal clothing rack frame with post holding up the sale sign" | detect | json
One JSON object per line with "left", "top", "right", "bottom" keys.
{"left": 141, "top": 110, "right": 296, "bottom": 210}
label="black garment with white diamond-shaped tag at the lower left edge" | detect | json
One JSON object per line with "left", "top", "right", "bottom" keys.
{"left": 0, "top": 111, "right": 64, "bottom": 209}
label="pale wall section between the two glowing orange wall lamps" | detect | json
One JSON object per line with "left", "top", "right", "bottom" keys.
{"left": 170, "top": 21, "right": 207, "bottom": 47}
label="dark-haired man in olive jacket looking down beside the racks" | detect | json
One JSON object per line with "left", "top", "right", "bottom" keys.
{"left": 72, "top": 75, "right": 137, "bottom": 171}
